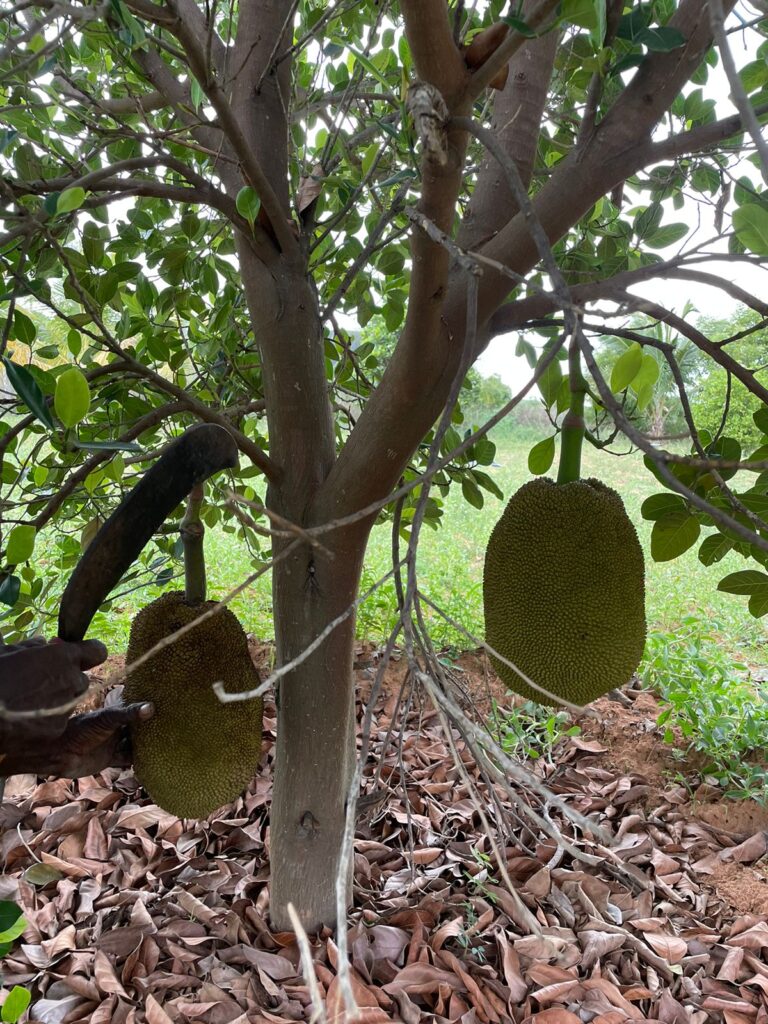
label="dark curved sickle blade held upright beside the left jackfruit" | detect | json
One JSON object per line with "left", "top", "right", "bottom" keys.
{"left": 58, "top": 423, "right": 238, "bottom": 640}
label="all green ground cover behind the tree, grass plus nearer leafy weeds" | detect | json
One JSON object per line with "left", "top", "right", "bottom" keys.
{"left": 27, "top": 419, "right": 768, "bottom": 799}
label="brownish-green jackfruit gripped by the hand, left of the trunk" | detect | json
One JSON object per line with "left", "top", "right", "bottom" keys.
{"left": 124, "top": 593, "right": 262, "bottom": 818}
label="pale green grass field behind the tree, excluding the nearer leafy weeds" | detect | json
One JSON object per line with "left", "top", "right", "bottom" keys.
{"left": 87, "top": 419, "right": 768, "bottom": 666}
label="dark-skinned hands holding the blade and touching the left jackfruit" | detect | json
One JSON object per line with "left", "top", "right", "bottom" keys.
{"left": 0, "top": 640, "right": 154, "bottom": 778}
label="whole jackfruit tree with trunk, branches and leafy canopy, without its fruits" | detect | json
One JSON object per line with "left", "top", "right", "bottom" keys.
{"left": 0, "top": 0, "right": 768, "bottom": 929}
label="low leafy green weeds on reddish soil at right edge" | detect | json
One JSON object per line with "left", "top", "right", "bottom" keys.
{"left": 641, "top": 616, "right": 768, "bottom": 803}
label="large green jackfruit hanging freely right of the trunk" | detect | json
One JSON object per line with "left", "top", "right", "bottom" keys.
{"left": 483, "top": 478, "right": 645, "bottom": 705}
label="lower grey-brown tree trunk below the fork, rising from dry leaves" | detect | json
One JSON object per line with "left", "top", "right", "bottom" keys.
{"left": 269, "top": 531, "right": 366, "bottom": 931}
